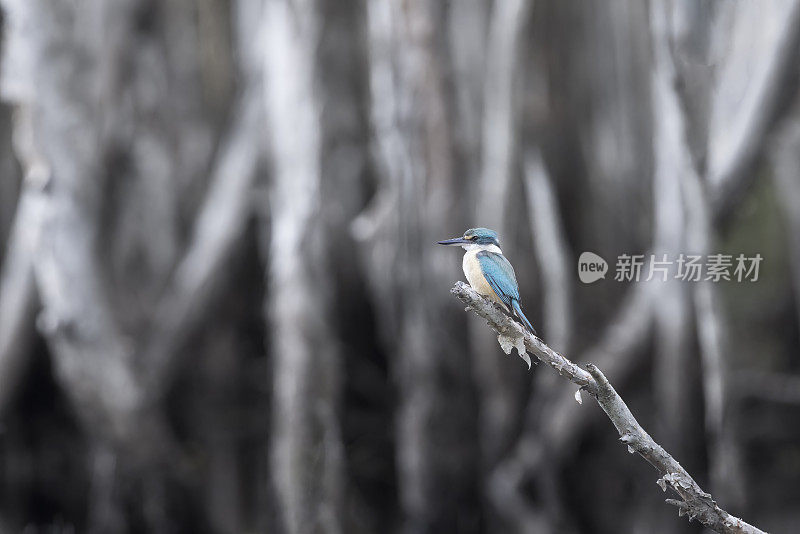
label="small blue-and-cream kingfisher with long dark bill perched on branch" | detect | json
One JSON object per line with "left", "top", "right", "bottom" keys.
{"left": 438, "top": 228, "right": 536, "bottom": 335}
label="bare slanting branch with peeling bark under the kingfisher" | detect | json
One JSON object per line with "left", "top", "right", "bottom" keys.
{"left": 450, "top": 282, "right": 763, "bottom": 534}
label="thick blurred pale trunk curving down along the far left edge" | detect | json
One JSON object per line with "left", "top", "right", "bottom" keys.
{"left": 3, "top": 2, "right": 184, "bottom": 530}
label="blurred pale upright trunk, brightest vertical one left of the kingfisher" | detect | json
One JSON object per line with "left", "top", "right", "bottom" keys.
{"left": 262, "top": 1, "right": 344, "bottom": 534}
